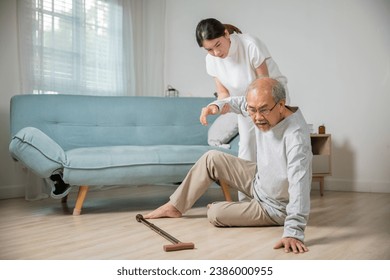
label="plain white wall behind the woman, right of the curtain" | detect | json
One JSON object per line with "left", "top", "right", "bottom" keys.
{"left": 165, "top": 0, "right": 390, "bottom": 192}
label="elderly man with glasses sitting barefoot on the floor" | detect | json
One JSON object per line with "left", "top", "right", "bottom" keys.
{"left": 145, "top": 78, "right": 312, "bottom": 253}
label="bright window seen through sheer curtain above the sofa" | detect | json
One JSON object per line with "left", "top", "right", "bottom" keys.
{"left": 23, "top": 0, "right": 124, "bottom": 95}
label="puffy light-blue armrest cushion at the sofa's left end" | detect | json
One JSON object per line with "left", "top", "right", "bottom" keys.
{"left": 9, "top": 127, "right": 66, "bottom": 178}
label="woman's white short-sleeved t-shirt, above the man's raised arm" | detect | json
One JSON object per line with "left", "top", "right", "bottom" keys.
{"left": 206, "top": 33, "right": 287, "bottom": 96}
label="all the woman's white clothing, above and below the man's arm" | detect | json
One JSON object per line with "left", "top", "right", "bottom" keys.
{"left": 206, "top": 33, "right": 289, "bottom": 168}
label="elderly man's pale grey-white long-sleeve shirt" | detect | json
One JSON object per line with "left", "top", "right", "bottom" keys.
{"left": 212, "top": 96, "right": 313, "bottom": 241}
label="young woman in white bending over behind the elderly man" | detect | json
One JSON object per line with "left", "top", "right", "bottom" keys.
{"left": 196, "top": 18, "right": 288, "bottom": 164}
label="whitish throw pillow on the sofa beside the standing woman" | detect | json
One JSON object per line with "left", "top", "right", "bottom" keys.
{"left": 208, "top": 113, "right": 238, "bottom": 148}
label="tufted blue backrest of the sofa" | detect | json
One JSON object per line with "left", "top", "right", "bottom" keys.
{"left": 11, "top": 95, "right": 221, "bottom": 151}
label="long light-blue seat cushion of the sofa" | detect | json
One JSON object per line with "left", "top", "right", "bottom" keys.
{"left": 64, "top": 145, "right": 235, "bottom": 185}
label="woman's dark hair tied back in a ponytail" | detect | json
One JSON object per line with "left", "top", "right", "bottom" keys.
{"left": 195, "top": 18, "right": 242, "bottom": 47}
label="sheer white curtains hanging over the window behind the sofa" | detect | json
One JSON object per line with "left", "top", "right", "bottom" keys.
{"left": 18, "top": 0, "right": 166, "bottom": 199}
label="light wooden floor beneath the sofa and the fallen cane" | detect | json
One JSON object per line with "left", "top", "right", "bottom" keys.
{"left": 0, "top": 186, "right": 390, "bottom": 260}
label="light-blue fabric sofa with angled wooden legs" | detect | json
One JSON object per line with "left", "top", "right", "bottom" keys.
{"left": 9, "top": 94, "right": 238, "bottom": 215}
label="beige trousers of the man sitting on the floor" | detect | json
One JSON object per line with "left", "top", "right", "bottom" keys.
{"left": 170, "top": 151, "right": 276, "bottom": 226}
